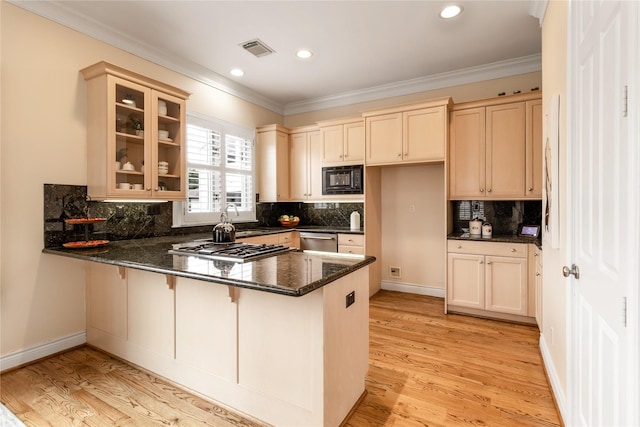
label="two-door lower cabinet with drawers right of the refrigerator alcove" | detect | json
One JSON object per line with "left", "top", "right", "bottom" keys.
{"left": 447, "top": 240, "right": 532, "bottom": 316}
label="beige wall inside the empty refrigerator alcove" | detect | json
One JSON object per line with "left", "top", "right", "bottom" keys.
{"left": 378, "top": 164, "right": 447, "bottom": 291}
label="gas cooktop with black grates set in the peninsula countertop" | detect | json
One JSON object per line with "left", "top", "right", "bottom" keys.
{"left": 169, "top": 240, "right": 293, "bottom": 262}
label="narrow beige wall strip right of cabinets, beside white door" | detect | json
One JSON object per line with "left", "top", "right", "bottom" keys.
{"left": 541, "top": 1, "right": 569, "bottom": 400}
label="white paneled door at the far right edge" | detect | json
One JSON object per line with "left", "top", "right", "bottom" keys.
{"left": 567, "top": 1, "right": 639, "bottom": 426}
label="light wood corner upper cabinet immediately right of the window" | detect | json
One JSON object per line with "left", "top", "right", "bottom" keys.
{"left": 256, "top": 125, "right": 289, "bottom": 203}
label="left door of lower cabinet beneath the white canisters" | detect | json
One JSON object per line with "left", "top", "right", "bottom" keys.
{"left": 447, "top": 253, "right": 485, "bottom": 310}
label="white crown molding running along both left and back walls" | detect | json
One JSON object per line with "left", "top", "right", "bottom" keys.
{"left": 6, "top": 0, "right": 546, "bottom": 116}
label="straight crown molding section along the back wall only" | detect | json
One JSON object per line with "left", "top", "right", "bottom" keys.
{"left": 284, "top": 54, "right": 542, "bottom": 116}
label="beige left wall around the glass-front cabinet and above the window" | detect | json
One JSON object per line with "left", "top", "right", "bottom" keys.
{"left": 0, "top": 1, "right": 283, "bottom": 356}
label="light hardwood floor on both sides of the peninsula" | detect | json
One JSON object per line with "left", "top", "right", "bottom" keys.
{"left": 0, "top": 291, "right": 560, "bottom": 427}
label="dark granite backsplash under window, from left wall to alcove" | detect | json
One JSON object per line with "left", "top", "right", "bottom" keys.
{"left": 44, "top": 184, "right": 364, "bottom": 248}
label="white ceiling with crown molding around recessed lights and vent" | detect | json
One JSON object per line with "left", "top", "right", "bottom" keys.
{"left": 12, "top": 0, "right": 541, "bottom": 114}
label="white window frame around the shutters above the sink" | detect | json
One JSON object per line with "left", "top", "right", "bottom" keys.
{"left": 173, "top": 112, "right": 256, "bottom": 227}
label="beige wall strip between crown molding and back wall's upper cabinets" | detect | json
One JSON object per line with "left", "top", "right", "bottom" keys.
{"left": 284, "top": 72, "right": 542, "bottom": 127}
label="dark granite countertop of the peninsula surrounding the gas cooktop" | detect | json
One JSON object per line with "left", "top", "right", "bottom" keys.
{"left": 42, "top": 234, "right": 376, "bottom": 296}
